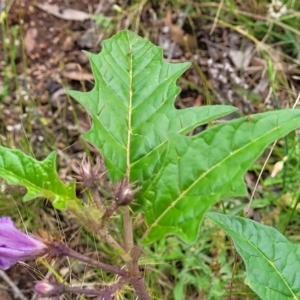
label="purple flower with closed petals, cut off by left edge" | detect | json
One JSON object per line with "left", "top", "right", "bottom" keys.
{"left": 0, "top": 217, "right": 47, "bottom": 270}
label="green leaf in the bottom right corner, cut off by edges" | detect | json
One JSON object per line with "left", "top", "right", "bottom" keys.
{"left": 206, "top": 213, "right": 300, "bottom": 300}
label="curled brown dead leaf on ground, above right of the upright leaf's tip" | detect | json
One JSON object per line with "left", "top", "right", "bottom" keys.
{"left": 164, "top": 10, "right": 196, "bottom": 51}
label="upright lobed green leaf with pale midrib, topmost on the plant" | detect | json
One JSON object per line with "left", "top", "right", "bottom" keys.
{"left": 67, "top": 31, "right": 236, "bottom": 183}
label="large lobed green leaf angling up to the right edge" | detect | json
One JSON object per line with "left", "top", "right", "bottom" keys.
{"left": 143, "top": 110, "right": 300, "bottom": 243}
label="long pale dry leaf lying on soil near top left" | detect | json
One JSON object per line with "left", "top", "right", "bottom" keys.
{"left": 36, "top": 3, "right": 92, "bottom": 21}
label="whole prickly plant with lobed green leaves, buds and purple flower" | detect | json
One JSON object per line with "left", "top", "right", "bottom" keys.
{"left": 0, "top": 31, "right": 300, "bottom": 300}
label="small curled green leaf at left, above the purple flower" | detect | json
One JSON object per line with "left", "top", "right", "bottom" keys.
{"left": 0, "top": 146, "right": 80, "bottom": 210}
